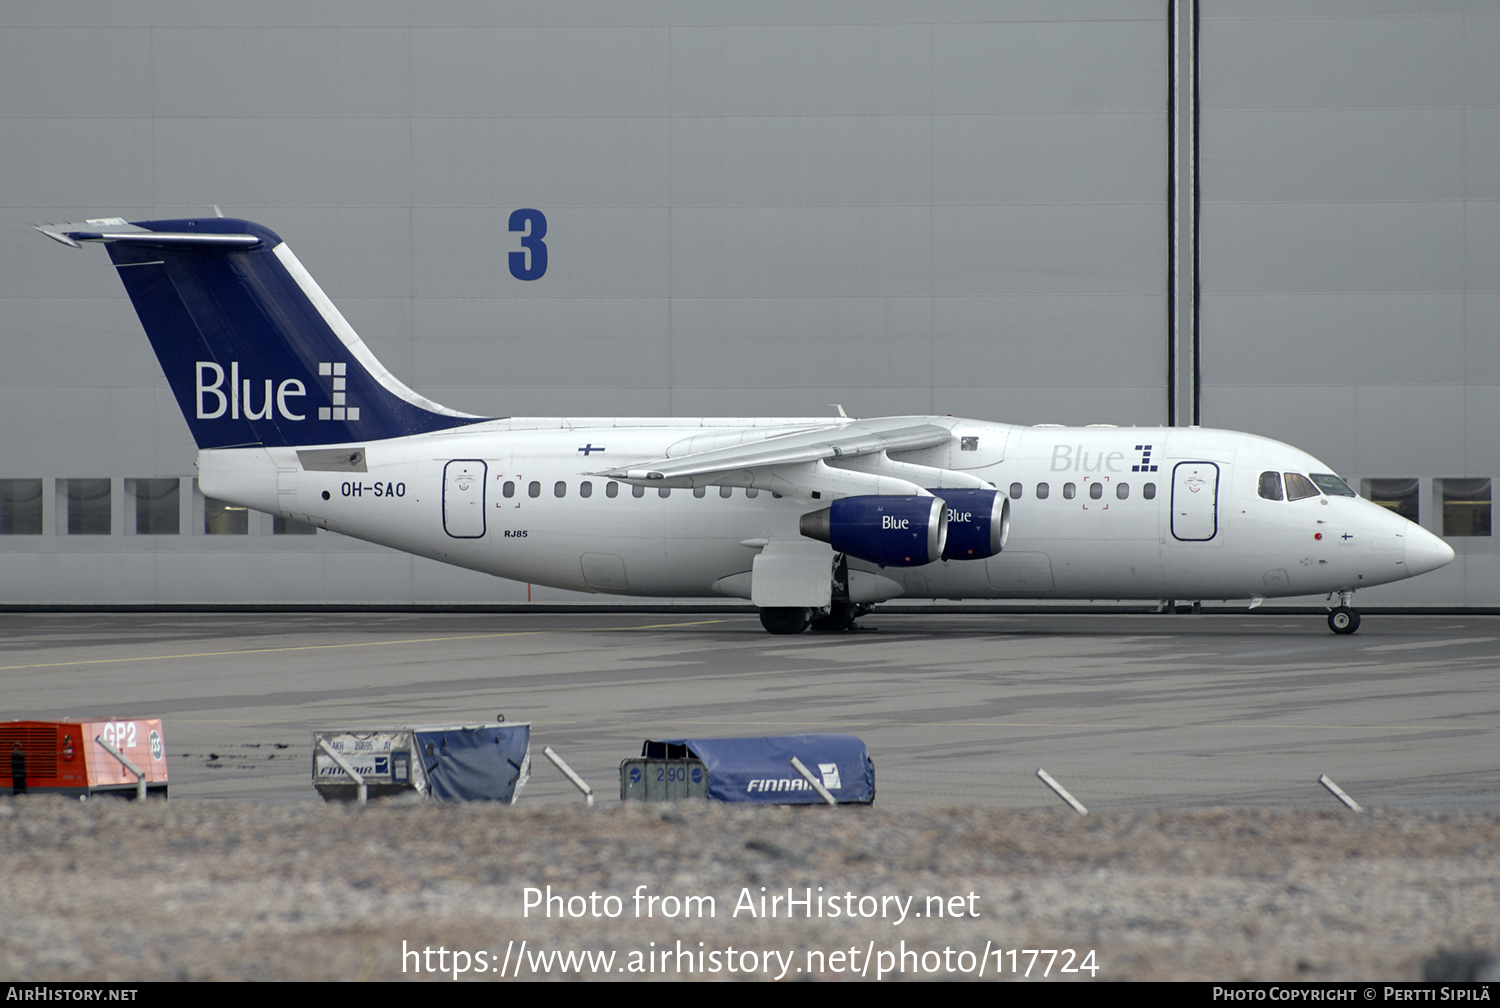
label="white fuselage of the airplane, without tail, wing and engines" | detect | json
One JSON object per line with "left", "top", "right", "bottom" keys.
{"left": 198, "top": 417, "right": 1454, "bottom": 602}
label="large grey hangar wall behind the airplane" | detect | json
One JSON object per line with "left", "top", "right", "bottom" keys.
{"left": 0, "top": 0, "right": 1500, "bottom": 606}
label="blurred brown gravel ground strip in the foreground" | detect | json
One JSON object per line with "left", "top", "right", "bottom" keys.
{"left": 0, "top": 797, "right": 1500, "bottom": 981}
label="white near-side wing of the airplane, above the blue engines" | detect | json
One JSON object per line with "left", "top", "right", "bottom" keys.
{"left": 590, "top": 417, "right": 990, "bottom": 501}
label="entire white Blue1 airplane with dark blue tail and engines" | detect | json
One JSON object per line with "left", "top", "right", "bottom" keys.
{"left": 38, "top": 218, "right": 1454, "bottom": 621}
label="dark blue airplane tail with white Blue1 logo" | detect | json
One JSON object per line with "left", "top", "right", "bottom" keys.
{"left": 36, "top": 218, "right": 483, "bottom": 449}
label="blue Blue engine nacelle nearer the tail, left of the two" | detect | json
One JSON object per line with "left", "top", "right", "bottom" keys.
{"left": 801, "top": 495, "right": 948, "bottom": 567}
